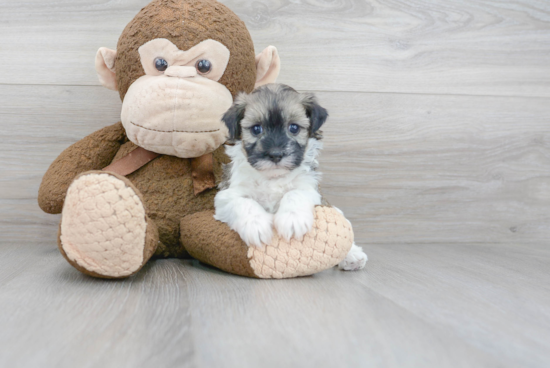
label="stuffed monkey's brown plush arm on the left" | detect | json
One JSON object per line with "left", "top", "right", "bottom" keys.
{"left": 38, "top": 122, "right": 126, "bottom": 214}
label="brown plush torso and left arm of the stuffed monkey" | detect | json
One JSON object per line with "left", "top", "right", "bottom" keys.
{"left": 38, "top": 123, "right": 233, "bottom": 258}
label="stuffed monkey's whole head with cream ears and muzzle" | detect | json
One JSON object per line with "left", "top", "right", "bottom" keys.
{"left": 95, "top": 0, "right": 280, "bottom": 158}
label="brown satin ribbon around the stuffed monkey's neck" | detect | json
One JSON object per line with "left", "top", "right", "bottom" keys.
{"left": 103, "top": 147, "right": 216, "bottom": 196}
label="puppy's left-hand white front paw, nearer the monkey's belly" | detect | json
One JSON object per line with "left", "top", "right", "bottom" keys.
{"left": 214, "top": 189, "right": 273, "bottom": 248}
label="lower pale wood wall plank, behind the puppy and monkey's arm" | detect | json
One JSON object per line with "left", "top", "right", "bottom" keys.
{"left": 0, "top": 86, "right": 550, "bottom": 244}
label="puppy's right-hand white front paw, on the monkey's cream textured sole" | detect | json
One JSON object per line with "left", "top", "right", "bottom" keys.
{"left": 274, "top": 190, "right": 321, "bottom": 241}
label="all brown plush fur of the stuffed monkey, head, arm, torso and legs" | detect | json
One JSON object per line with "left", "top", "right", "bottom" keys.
{"left": 38, "top": 0, "right": 351, "bottom": 277}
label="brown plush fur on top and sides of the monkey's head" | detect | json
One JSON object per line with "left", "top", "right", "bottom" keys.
{"left": 115, "top": 0, "right": 256, "bottom": 99}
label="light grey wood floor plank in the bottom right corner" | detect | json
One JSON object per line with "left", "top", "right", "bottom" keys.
{"left": 364, "top": 242, "right": 550, "bottom": 367}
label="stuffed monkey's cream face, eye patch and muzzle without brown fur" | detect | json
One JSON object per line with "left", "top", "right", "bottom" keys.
{"left": 122, "top": 39, "right": 233, "bottom": 158}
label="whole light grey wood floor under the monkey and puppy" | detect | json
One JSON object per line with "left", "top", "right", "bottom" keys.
{"left": 0, "top": 242, "right": 550, "bottom": 368}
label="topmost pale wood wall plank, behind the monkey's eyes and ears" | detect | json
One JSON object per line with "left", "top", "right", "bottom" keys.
{"left": 0, "top": 0, "right": 550, "bottom": 97}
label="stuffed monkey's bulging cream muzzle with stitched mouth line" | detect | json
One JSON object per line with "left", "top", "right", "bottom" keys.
{"left": 120, "top": 76, "right": 233, "bottom": 158}
